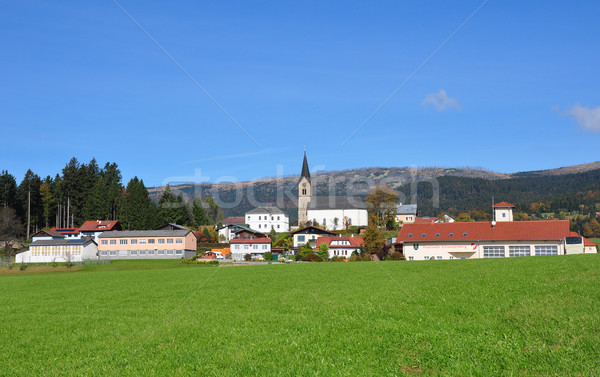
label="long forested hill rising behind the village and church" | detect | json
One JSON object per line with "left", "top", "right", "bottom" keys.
{"left": 149, "top": 162, "right": 600, "bottom": 222}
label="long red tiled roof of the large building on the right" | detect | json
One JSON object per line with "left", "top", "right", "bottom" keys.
{"left": 397, "top": 220, "right": 570, "bottom": 242}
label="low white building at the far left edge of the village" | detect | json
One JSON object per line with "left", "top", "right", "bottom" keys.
{"left": 15, "top": 239, "right": 98, "bottom": 263}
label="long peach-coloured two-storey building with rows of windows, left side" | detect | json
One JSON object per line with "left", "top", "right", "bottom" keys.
{"left": 98, "top": 229, "right": 197, "bottom": 259}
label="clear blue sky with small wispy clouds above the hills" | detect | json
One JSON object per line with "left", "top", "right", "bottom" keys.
{"left": 0, "top": 0, "right": 600, "bottom": 186}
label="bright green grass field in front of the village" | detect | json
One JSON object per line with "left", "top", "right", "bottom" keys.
{"left": 0, "top": 255, "right": 600, "bottom": 376}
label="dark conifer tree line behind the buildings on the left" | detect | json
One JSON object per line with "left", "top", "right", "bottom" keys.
{"left": 0, "top": 157, "right": 223, "bottom": 239}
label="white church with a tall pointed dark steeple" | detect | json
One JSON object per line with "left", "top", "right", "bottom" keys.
{"left": 298, "top": 151, "right": 369, "bottom": 230}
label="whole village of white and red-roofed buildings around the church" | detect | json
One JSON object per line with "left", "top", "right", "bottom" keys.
{"left": 15, "top": 152, "right": 597, "bottom": 264}
